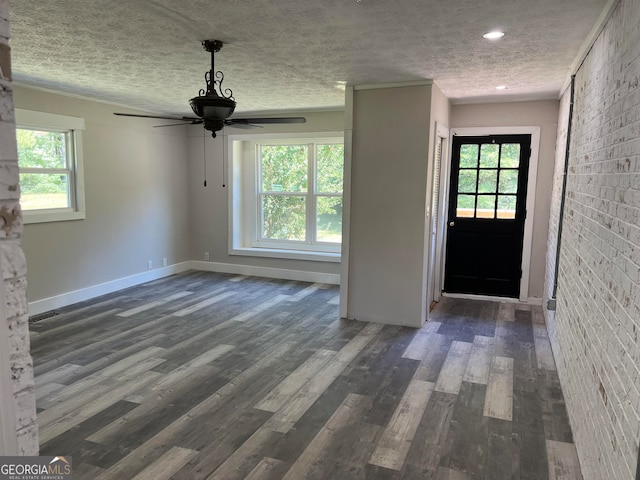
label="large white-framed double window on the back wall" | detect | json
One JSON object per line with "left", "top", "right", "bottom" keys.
{"left": 230, "top": 136, "right": 344, "bottom": 261}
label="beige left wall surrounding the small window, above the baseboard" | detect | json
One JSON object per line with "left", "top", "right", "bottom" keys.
{"left": 15, "top": 87, "right": 190, "bottom": 302}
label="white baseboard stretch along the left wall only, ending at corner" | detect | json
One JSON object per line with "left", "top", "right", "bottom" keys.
{"left": 29, "top": 262, "right": 191, "bottom": 316}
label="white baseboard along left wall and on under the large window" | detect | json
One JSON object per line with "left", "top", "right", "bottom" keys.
{"left": 29, "top": 260, "right": 340, "bottom": 316}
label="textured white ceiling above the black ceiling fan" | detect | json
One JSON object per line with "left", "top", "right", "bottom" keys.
{"left": 7, "top": 0, "right": 607, "bottom": 114}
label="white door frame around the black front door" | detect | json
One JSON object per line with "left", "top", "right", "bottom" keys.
{"left": 440, "top": 126, "right": 540, "bottom": 303}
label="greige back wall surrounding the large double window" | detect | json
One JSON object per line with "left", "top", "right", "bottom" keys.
{"left": 188, "top": 110, "right": 344, "bottom": 275}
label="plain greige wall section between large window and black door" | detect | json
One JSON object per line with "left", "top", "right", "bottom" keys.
{"left": 347, "top": 85, "right": 432, "bottom": 327}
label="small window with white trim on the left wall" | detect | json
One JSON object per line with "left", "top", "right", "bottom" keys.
{"left": 16, "top": 110, "right": 85, "bottom": 223}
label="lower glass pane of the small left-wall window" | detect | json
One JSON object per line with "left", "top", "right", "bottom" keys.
{"left": 20, "top": 173, "right": 71, "bottom": 210}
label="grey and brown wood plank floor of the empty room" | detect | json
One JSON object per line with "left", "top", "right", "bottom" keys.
{"left": 31, "top": 272, "right": 581, "bottom": 480}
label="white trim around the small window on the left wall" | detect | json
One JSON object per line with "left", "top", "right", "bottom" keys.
{"left": 15, "top": 109, "right": 86, "bottom": 224}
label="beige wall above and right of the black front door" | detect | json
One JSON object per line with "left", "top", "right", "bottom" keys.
{"left": 451, "top": 100, "right": 559, "bottom": 299}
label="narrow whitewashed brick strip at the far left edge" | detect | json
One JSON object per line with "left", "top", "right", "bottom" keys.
{"left": 0, "top": 0, "right": 38, "bottom": 455}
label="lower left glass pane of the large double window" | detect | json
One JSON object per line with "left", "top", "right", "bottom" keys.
{"left": 262, "top": 195, "right": 306, "bottom": 240}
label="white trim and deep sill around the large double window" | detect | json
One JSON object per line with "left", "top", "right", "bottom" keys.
{"left": 229, "top": 131, "right": 344, "bottom": 263}
